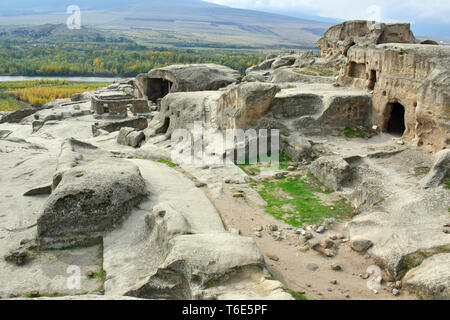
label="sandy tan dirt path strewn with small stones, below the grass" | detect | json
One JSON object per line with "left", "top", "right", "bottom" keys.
{"left": 210, "top": 190, "right": 416, "bottom": 300}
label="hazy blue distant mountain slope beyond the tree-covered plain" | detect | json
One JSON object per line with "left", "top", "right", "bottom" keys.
{"left": 0, "top": 0, "right": 330, "bottom": 48}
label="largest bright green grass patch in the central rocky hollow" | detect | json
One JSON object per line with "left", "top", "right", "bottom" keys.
{"left": 256, "top": 175, "right": 353, "bottom": 227}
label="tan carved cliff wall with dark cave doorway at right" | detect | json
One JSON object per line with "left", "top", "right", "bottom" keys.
{"left": 339, "top": 44, "right": 450, "bottom": 151}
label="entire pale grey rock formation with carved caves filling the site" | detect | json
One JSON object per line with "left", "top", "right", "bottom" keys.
{"left": 0, "top": 21, "right": 450, "bottom": 299}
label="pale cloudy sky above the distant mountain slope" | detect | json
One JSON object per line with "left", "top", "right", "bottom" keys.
{"left": 205, "top": 0, "right": 450, "bottom": 26}
